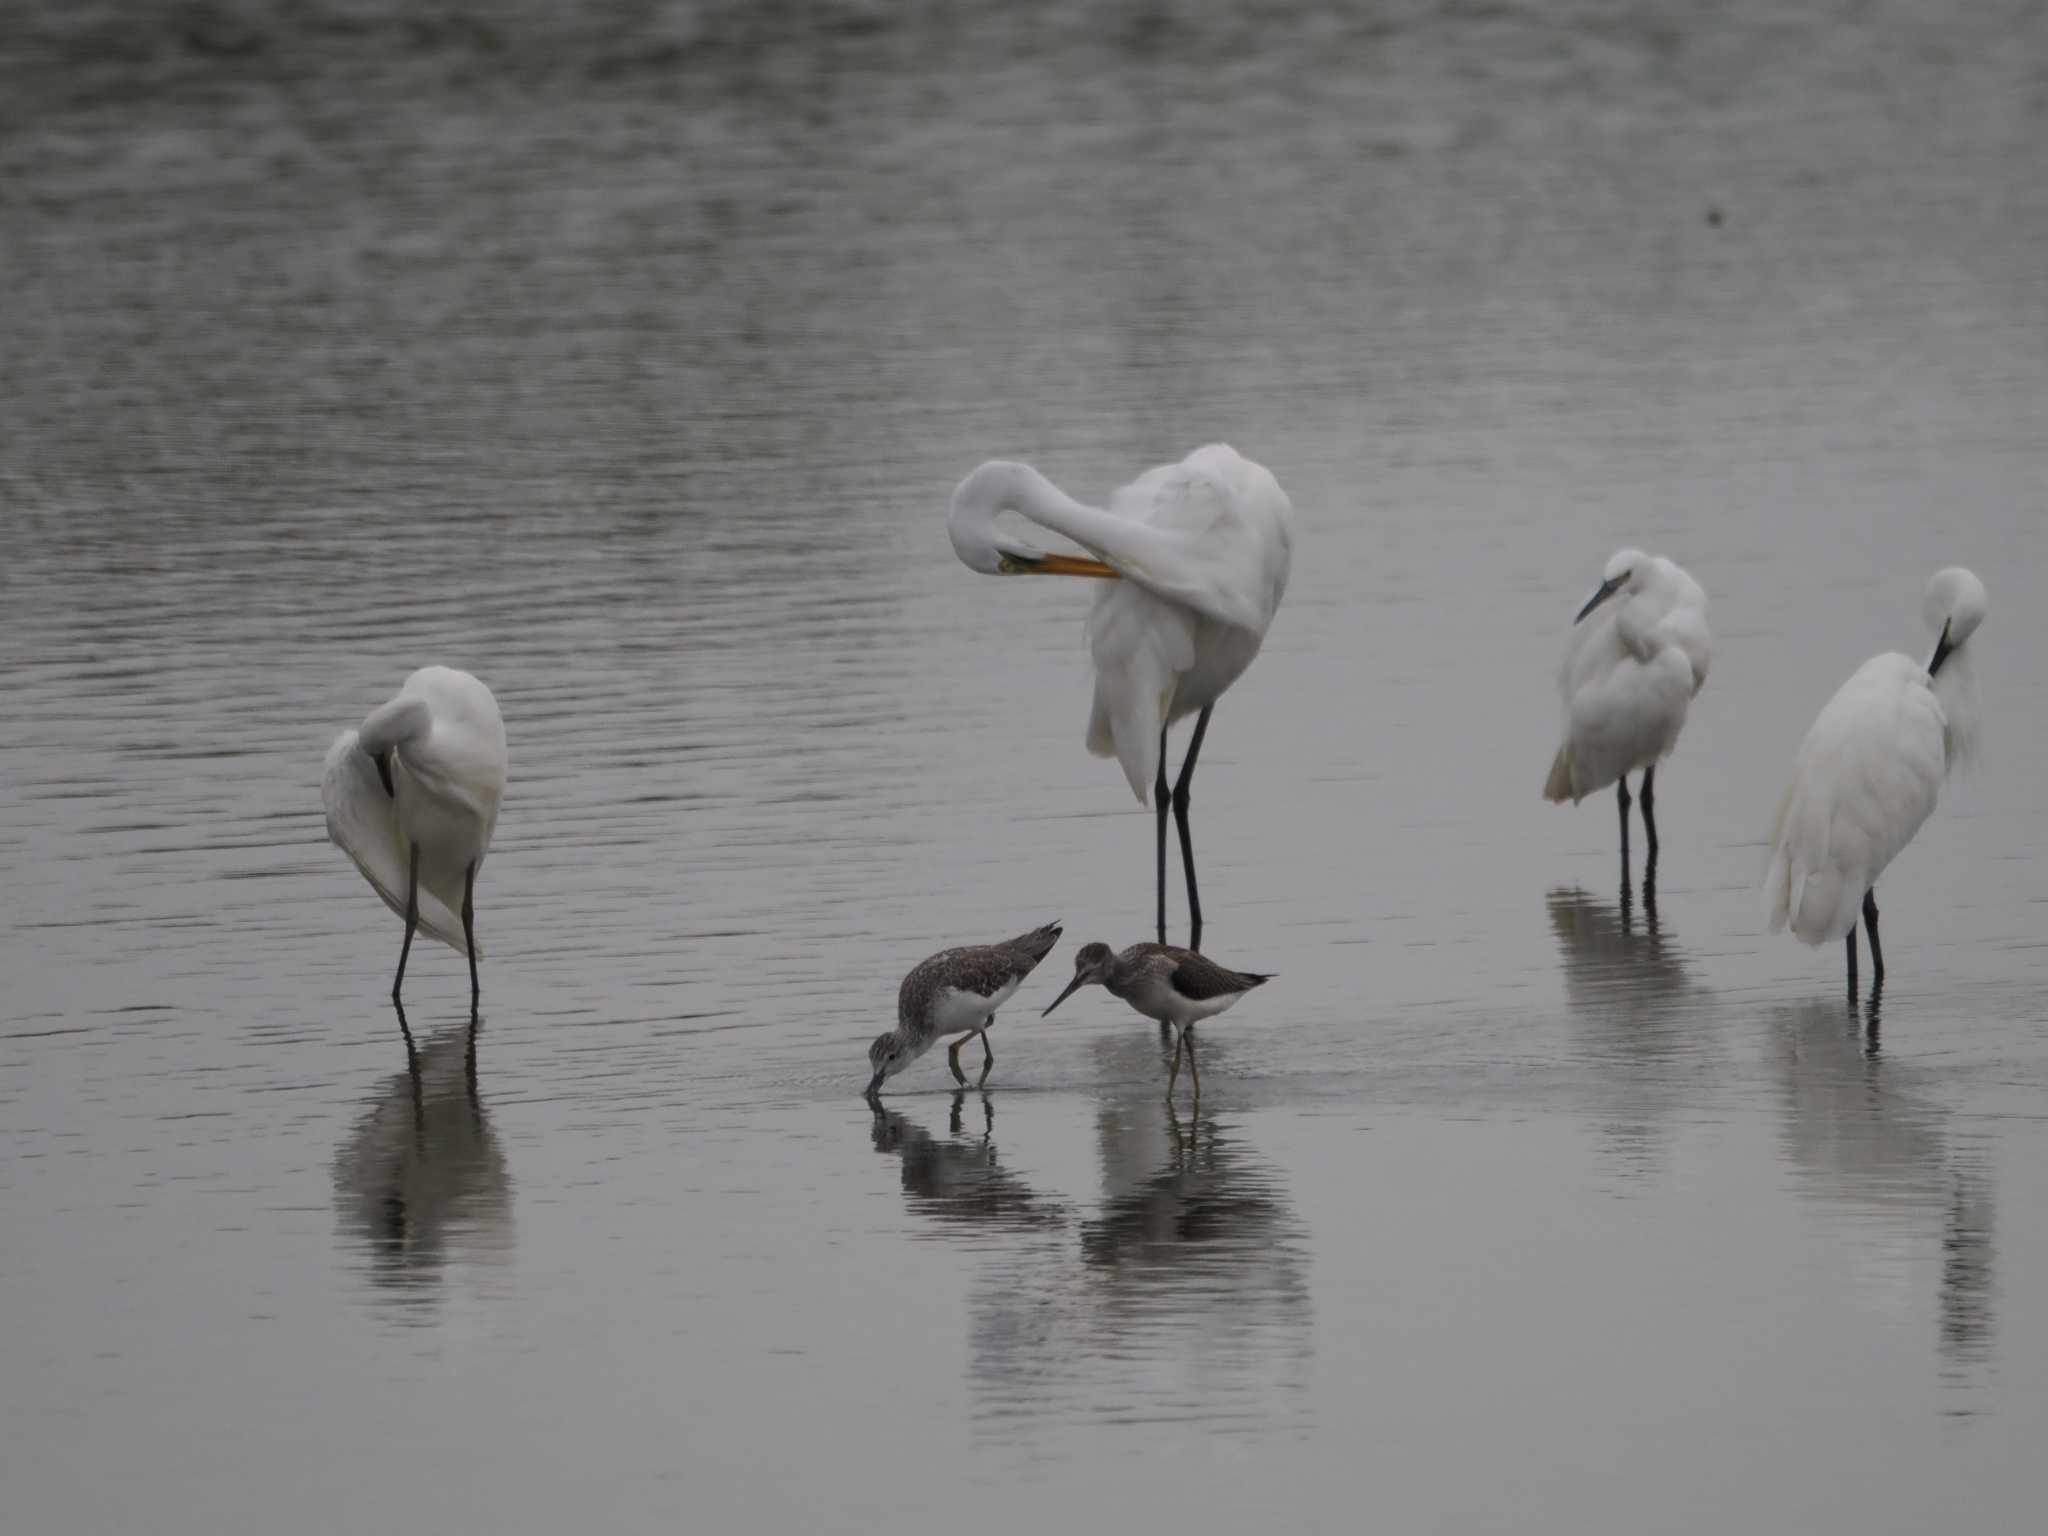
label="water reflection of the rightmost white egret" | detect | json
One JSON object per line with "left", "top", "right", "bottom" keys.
{"left": 1772, "top": 1003, "right": 1997, "bottom": 1411}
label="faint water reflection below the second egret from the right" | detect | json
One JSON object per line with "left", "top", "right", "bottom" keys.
{"left": 1544, "top": 884, "right": 1718, "bottom": 1176}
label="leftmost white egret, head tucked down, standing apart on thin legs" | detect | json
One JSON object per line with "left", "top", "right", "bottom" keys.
{"left": 319, "top": 668, "right": 506, "bottom": 1024}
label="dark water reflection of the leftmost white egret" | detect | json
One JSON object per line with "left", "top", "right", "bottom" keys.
{"left": 334, "top": 1028, "right": 512, "bottom": 1321}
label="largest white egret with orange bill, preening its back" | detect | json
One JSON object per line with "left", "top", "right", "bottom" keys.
{"left": 946, "top": 442, "right": 1294, "bottom": 948}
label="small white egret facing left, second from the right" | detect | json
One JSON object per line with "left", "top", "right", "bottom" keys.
{"left": 1542, "top": 549, "right": 1714, "bottom": 881}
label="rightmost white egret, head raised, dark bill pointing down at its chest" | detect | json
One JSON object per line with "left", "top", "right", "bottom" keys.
{"left": 1763, "top": 565, "right": 1989, "bottom": 993}
